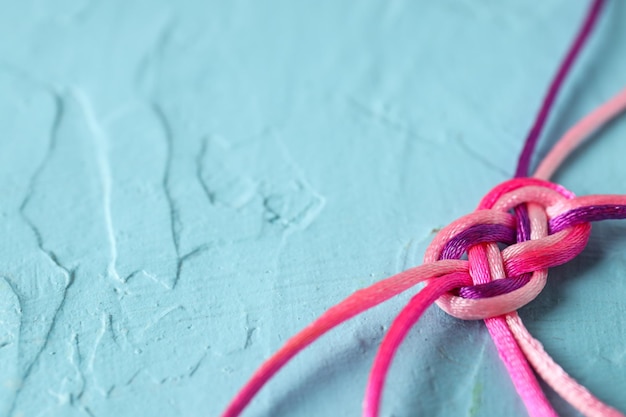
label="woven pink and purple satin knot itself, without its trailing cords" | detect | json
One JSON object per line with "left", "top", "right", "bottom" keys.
{"left": 424, "top": 178, "right": 591, "bottom": 320}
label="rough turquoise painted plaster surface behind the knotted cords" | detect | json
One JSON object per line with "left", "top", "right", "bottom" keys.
{"left": 0, "top": 0, "right": 626, "bottom": 417}
